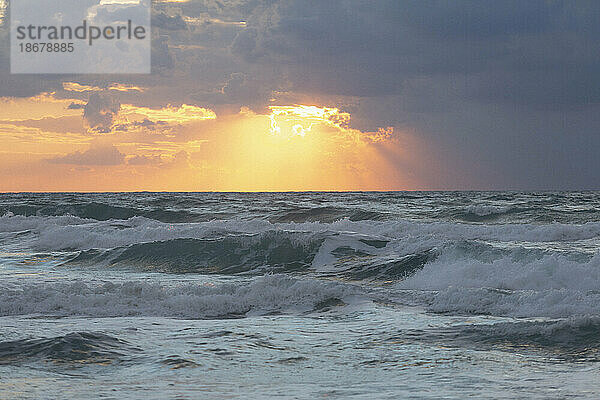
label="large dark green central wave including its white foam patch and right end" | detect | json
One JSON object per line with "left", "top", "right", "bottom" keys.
{"left": 62, "top": 230, "right": 422, "bottom": 281}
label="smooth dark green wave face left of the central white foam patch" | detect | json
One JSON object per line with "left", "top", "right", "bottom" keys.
{"left": 65, "top": 231, "right": 323, "bottom": 274}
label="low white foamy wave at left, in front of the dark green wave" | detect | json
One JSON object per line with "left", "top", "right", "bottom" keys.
{"left": 0, "top": 275, "right": 360, "bottom": 319}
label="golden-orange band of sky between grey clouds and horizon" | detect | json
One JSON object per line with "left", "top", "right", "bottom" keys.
{"left": 0, "top": 91, "right": 422, "bottom": 191}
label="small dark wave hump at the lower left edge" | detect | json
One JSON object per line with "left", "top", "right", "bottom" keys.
{"left": 0, "top": 332, "right": 137, "bottom": 364}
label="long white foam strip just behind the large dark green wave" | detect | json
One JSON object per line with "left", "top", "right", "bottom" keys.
{"left": 0, "top": 214, "right": 600, "bottom": 250}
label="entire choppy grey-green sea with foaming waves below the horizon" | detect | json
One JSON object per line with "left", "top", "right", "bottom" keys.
{"left": 0, "top": 192, "right": 600, "bottom": 399}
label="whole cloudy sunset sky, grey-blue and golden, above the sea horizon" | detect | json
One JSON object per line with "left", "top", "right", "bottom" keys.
{"left": 0, "top": 0, "right": 600, "bottom": 192}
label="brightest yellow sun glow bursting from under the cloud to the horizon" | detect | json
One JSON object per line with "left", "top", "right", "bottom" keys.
{"left": 197, "top": 105, "right": 407, "bottom": 191}
